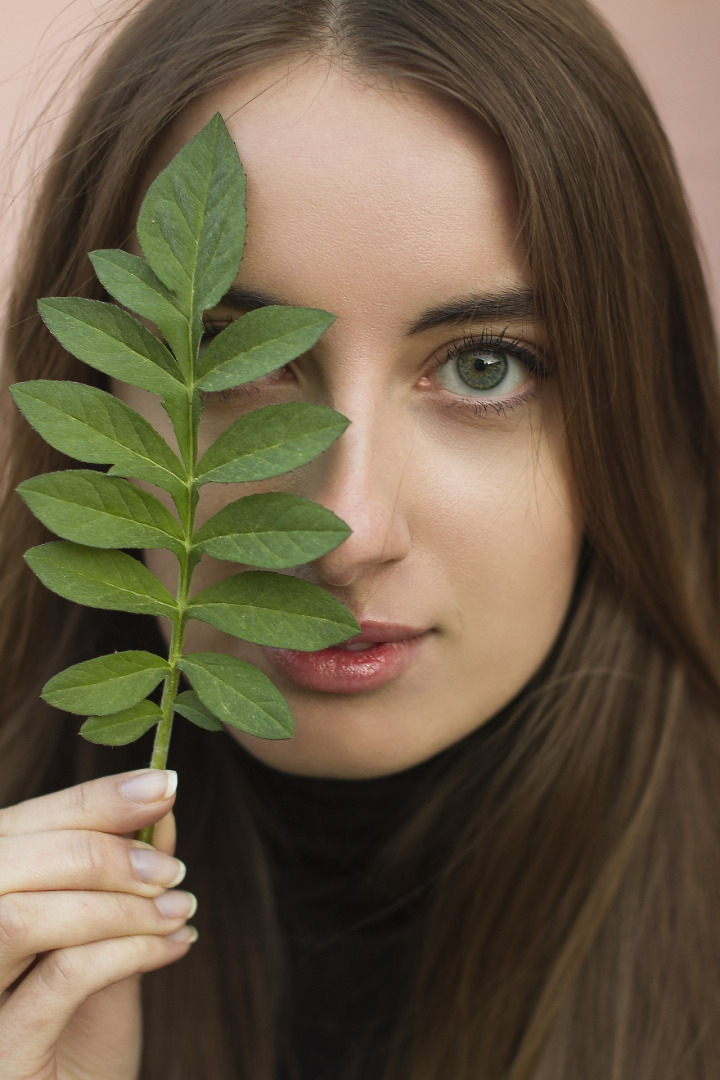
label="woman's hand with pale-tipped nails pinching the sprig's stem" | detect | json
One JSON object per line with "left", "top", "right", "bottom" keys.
{"left": 0, "top": 770, "right": 196, "bottom": 1080}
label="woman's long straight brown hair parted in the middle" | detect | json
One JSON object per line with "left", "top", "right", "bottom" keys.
{"left": 0, "top": 0, "right": 720, "bottom": 1080}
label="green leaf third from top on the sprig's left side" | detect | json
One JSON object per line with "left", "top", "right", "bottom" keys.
{"left": 10, "top": 379, "right": 186, "bottom": 497}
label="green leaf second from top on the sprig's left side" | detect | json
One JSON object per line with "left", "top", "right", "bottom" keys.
{"left": 38, "top": 296, "right": 185, "bottom": 397}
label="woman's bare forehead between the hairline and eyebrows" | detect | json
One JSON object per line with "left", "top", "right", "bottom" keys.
{"left": 139, "top": 58, "right": 528, "bottom": 311}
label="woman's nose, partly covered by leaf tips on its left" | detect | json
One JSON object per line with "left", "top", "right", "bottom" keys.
{"left": 304, "top": 409, "right": 412, "bottom": 588}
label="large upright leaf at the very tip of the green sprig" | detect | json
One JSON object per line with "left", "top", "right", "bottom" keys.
{"left": 137, "top": 113, "right": 245, "bottom": 318}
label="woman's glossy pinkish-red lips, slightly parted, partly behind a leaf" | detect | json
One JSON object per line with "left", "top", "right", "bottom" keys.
{"left": 261, "top": 620, "right": 432, "bottom": 693}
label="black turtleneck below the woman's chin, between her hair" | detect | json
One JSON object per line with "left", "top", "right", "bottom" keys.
{"left": 231, "top": 714, "right": 518, "bottom": 1080}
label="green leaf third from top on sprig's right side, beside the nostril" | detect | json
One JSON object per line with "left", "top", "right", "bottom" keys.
{"left": 193, "top": 491, "right": 350, "bottom": 570}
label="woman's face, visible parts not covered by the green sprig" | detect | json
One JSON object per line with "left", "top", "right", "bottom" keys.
{"left": 114, "top": 59, "right": 581, "bottom": 778}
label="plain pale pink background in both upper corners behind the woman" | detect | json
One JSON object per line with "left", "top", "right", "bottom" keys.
{"left": 0, "top": 0, "right": 720, "bottom": 313}
